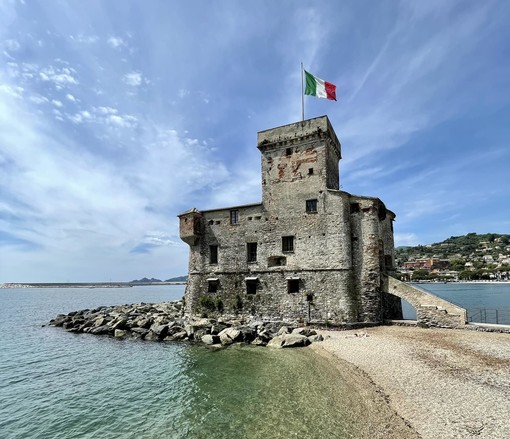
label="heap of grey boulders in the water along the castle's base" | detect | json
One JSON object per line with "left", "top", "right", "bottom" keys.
{"left": 49, "top": 301, "right": 322, "bottom": 348}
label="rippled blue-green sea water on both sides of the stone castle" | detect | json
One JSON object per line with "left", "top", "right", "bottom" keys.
{"left": 0, "top": 284, "right": 510, "bottom": 439}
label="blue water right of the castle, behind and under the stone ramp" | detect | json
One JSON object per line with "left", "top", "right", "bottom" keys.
{"left": 402, "top": 282, "right": 510, "bottom": 325}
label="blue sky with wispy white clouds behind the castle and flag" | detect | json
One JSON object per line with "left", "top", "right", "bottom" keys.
{"left": 0, "top": 0, "right": 510, "bottom": 283}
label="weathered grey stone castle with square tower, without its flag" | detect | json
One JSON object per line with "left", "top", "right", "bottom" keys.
{"left": 179, "top": 116, "right": 401, "bottom": 323}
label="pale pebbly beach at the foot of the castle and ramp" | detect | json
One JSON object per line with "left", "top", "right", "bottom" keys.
{"left": 312, "top": 326, "right": 510, "bottom": 439}
